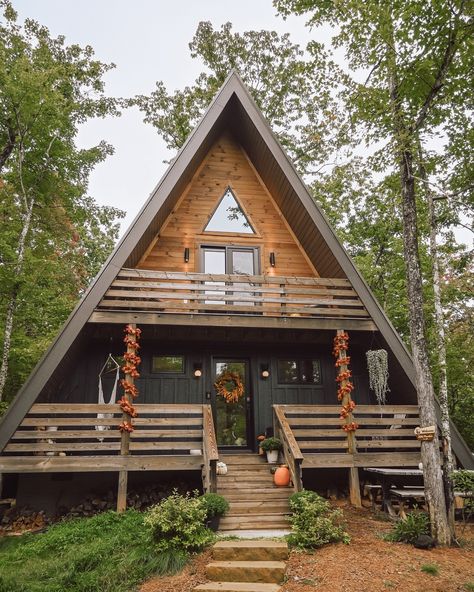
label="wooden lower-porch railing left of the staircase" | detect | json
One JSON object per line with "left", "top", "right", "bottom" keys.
{"left": 0, "top": 404, "right": 215, "bottom": 473}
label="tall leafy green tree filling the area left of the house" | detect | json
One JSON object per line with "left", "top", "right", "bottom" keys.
{"left": 0, "top": 0, "right": 123, "bottom": 400}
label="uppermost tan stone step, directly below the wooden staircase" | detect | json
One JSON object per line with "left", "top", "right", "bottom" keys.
{"left": 212, "top": 539, "right": 288, "bottom": 561}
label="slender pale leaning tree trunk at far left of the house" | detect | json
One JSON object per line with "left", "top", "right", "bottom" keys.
{"left": 0, "top": 198, "right": 35, "bottom": 401}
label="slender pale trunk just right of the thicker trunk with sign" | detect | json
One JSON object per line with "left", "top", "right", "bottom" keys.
{"left": 418, "top": 145, "right": 455, "bottom": 538}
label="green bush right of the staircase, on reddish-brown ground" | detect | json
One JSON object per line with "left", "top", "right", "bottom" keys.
{"left": 288, "top": 491, "right": 350, "bottom": 549}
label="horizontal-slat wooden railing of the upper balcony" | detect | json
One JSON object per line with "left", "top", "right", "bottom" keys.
{"left": 96, "top": 269, "right": 369, "bottom": 320}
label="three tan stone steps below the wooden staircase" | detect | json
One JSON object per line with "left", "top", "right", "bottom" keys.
{"left": 194, "top": 540, "right": 288, "bottom": 592}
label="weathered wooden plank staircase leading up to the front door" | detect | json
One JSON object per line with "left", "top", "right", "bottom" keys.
{"left": 217, "top": 453, "right": 294, "bottom": 531}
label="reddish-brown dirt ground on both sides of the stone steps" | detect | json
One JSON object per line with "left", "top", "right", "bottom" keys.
{"left": 140, "top": 507, "right": 474, "bottom": 592}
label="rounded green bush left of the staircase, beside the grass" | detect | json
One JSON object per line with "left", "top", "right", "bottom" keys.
{"left": 145, "top": 490, "right": 214, "bottom": 553}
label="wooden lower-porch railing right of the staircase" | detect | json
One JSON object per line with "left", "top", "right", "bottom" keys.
{"left": 274, "top": 405, "right": 421, "bottom": 468}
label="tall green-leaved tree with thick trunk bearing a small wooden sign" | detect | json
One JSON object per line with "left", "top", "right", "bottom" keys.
{"left": 275, "top": 0, "right": 473, "bottom": 543}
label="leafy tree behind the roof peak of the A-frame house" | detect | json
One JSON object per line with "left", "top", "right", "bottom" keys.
{"left": 132, "top": 22, "right": 349, "bottom": 172}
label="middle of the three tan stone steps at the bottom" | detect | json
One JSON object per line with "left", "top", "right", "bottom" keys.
{"left": 206, "top": 561, "right": 286, "bottom": 584}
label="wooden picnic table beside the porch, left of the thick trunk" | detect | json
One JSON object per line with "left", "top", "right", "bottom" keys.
{"left": 365, "top": 467, "right": 425, "bottom": 518}
